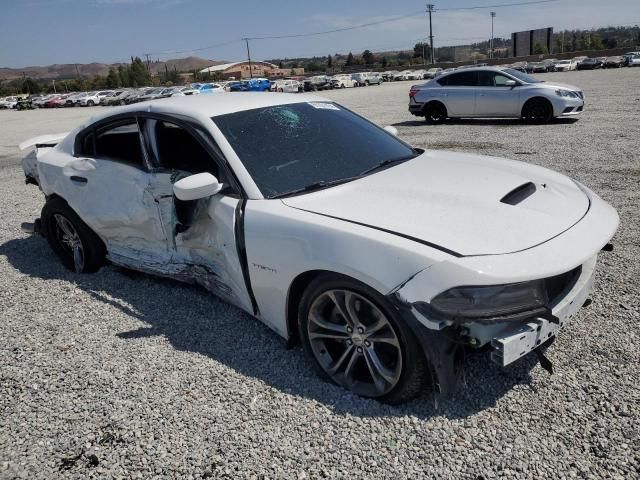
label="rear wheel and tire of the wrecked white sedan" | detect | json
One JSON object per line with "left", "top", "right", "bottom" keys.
{"left": 42, "top": 197, "right": 106, "bottom": 273}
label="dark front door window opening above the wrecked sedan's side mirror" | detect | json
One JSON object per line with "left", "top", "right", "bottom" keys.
{"left": 154, "top": 120, "right": 220, "bottom": 179}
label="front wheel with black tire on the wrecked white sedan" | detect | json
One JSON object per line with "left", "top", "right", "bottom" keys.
{"left": 298, "top": 274, "right": 430, "bottom": 404}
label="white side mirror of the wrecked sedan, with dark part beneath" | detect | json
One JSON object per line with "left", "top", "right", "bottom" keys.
{"left": 173, "top": 172, "right": 223, "bottom": 233}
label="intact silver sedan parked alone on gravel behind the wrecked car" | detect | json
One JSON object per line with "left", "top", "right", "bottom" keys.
{"left": 409, "top": 67, "right": 584, "bottom": 123}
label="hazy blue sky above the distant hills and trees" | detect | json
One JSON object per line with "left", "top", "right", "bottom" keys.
{"left": 0, "top": 0, "right": 640, "bottom": 67}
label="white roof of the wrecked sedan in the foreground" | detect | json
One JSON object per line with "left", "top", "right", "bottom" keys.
{"left": 82, "top": 92, "right": 331, "bottom": 124}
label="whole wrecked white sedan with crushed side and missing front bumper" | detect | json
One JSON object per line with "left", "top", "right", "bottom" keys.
{"left": 21, "top": 93, "right": 618, "bottom": 403}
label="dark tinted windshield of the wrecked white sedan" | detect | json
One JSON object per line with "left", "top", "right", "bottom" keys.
{"left": 213, "top": 102, "right": 418, "bottom": 198}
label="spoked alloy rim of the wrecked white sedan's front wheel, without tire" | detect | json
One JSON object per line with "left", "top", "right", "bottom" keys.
{"left": 307, "top": 289, "right": 402, "bottom": 397}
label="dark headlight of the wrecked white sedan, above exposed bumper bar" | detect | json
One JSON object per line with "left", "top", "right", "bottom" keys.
{"left": 430, "top": 280, "right": 549, "bottom": 320}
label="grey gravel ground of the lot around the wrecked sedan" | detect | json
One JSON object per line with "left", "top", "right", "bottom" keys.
{"left": 0, "top": 69, "right": 640, "bottom": 479}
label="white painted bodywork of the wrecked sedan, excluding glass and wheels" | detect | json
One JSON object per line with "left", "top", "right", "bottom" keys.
{"left": 22, "top": 92, "right": 618, "bottom": 396}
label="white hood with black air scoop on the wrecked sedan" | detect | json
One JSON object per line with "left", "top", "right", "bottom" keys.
{"left": 282, "top": 151, "right": 589, "bottom": 256}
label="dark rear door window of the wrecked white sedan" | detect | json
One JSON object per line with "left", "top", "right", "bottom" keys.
{"left": 94, "top": 118, "right": 144, "bottom": 167}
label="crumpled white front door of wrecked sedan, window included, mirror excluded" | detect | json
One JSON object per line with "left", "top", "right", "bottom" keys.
{"left": 141, "top": 115, "right": 254, "bottom": 311}
